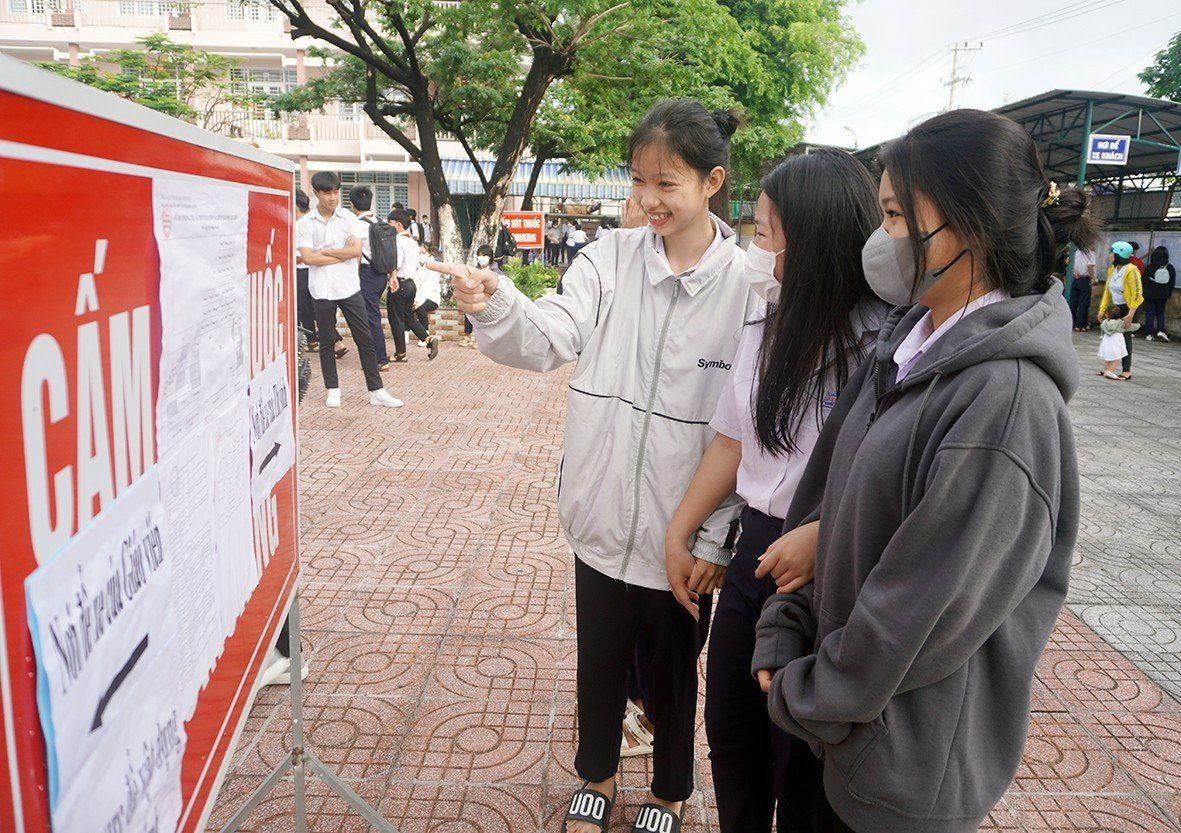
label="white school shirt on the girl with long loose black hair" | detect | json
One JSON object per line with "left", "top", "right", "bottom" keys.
{"left": 710, "top": 300, "right": 889, "bottom": 518}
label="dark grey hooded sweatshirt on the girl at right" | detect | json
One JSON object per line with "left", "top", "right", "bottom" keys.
{"left": 752, "top": 286, "right": 1078, "bottom": 833}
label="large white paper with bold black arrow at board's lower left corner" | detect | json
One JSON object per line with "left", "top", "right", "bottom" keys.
{"left": 25, "top": 469, "right": 185, "bottom": 833}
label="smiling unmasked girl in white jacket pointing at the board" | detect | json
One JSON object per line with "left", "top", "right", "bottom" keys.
{"left": 428, "top": 99, "right": 755, "bottom": 833}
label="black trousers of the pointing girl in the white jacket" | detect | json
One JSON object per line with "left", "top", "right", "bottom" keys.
{"left": 574, "top": 559, "right": 713, "bottom": 801}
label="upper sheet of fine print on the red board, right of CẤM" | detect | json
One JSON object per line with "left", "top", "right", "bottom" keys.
{"left": 152, "top": 180, "right": 249, "bottom": 458}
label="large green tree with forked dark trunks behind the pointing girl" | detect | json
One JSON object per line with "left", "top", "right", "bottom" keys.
{"left": 270, "top": 0, "right": 860, "bottom": 259}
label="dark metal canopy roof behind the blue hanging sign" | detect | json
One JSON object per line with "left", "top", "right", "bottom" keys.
{"left": 993, "top": 90, "right": 1181, "bottom": 186}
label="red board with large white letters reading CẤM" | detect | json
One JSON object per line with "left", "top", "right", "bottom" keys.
{"left": 0, "top": 56, "right": 299, "bottom": 833}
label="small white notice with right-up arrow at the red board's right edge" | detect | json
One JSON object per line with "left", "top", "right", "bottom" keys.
{"left": 250, "top": 353, "right": 295, "bottom": 507}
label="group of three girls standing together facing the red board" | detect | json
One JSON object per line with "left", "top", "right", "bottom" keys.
{"left": 430, "top": 99, "right": 1097, "bottom": 833}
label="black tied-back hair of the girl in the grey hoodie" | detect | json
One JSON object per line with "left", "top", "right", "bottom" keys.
{"left": 880, "top": 110, "right": 1101, "bottom": 297}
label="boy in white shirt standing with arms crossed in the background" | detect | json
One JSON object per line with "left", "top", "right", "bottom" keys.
{"left": 295, "top": 170, "right": 402, "bottom": 408}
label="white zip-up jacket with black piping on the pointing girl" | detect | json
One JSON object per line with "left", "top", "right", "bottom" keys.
{"left": 470, "top": 220, "right": 758, "bottom": 590}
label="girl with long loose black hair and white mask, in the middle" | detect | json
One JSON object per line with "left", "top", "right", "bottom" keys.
{"left": 665, "top": 149, "right": 889, "bottom": 833}
